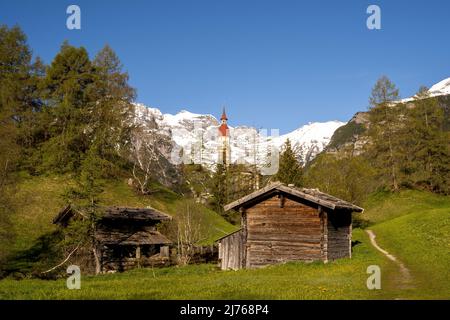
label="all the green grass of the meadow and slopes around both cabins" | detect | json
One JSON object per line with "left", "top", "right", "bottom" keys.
{"left": 0, "top": 177, "right": 450, "bottom": 299}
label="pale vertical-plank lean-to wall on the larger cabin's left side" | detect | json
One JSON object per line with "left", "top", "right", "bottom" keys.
{"left": 219, "top": 230, "right": 245, "bottom": 270}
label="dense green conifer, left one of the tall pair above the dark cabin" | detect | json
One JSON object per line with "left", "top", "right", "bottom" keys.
{"left": 41, "top": 43, "right": 95, "bottom": 172}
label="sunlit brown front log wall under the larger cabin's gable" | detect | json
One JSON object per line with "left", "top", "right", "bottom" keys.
{"left": 245, "top": 196, "right": 323, "bottom": 268}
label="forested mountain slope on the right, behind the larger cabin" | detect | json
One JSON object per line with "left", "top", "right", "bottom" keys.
{"left": 306, "top": 77, "right": 450, "bottom": 202}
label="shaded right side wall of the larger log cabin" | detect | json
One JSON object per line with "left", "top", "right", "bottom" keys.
{"left": 327, "top": 211, "right": 352, "bottom": 260}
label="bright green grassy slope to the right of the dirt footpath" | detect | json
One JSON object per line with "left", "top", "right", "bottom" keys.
{"left": 364, "top": 190, "right": 450, "bottom": 299}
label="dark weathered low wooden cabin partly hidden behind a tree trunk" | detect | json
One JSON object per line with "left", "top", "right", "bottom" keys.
{"left": 53, "top": 205, "right": 172, "bottom": 273}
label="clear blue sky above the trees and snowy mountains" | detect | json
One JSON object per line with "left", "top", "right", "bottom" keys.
{"left": 0, "top": 0, "right": 450, "bottom": 133}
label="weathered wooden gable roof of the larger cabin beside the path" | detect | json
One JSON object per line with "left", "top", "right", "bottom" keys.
{"left": 224, "top": 182, "right": 364, "bottom": 212}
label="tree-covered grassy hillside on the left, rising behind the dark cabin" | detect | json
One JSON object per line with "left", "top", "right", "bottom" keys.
{"left": 0, "top": 26, "right": 235, "bottom": 276}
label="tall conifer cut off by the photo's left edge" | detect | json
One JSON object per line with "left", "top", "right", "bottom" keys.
{"left": 0, "top": 26, "right": 36, "bottom": 254}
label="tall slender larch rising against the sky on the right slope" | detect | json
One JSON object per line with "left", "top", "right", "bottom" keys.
{"left": 369, "top": 76, "right": 401, "bottom": 191}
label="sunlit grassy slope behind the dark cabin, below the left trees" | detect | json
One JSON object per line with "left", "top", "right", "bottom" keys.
{"left": 0, "top": 176, "right": 235, "bottom": 262}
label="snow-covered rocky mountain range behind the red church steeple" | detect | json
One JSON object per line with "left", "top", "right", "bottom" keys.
{"left": 135, "top": 104, "right": 345, "bottom": 170}
